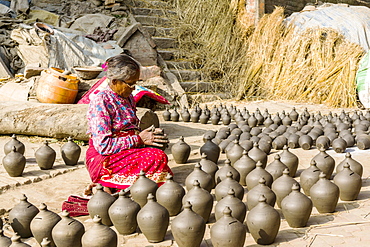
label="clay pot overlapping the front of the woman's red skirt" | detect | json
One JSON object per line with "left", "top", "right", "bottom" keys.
{"left": 130, "top": 170, "right": 158, "bottom": 208}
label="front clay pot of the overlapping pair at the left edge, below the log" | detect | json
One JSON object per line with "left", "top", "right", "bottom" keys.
{"left": 3, "top": 147, "right": 26, "bottom": 177}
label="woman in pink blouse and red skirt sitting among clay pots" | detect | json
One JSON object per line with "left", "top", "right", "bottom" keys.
{"left": 86, "top": 54, "right": 172, "bottom": 192}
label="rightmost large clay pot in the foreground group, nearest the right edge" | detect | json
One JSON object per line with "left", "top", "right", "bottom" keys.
{"left": 333, "top": 163, "right": 362, "bottom": 201}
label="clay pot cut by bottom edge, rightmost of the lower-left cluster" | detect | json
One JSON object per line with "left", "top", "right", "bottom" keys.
{"left": 81, "top": 215, "right": 118, "bottom": 247}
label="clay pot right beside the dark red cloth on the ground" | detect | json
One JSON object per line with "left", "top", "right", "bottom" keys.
{"left": 87, "top": 184, "right": 116, "bottom": 226}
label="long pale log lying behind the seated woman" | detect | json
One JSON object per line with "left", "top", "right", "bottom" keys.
{"left": 0, "top": 101, "right": 159, "bottom": 141}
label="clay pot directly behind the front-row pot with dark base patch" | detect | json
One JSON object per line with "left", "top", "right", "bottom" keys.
{"left": 247, "top": 178, "right": 276, "bottom": 210}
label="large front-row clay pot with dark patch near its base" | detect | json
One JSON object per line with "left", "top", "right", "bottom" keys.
{"left": 247, "top": 195, "right": 280, "bottom": 245}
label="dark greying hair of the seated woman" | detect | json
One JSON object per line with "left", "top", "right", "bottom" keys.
{"left": 106, "top": 54, "right": 140, "bottom": 81}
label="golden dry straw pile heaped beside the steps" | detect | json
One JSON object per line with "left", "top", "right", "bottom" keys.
{"left": 175, "top": 0, "right": 364, "bottom": 107}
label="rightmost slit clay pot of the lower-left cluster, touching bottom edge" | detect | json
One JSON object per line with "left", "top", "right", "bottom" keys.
{"left": 51, "top": 210, "right": 85, "bottom": 247}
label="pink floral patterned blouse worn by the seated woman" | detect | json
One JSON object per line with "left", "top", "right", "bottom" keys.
{"left": 87, "top": 86, "right": 143, "bottom": 155}
